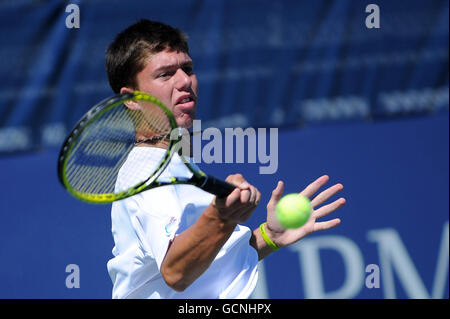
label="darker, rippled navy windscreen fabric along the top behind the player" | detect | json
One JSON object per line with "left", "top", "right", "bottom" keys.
{"left": 0, "top": 0, "right": 449, "bottom": 152}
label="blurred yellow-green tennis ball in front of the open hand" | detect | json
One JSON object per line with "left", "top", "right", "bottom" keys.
{"left": 275, "top": 193, "right": 311, "bottom": 228}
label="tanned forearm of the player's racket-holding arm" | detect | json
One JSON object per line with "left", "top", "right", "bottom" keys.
{"left": 161, "top": 206, "right": 236, "bottom": 291}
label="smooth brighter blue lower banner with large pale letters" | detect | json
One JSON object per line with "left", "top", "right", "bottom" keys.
{"left": 0, "top": 114, "right": 449, "bottom": 299}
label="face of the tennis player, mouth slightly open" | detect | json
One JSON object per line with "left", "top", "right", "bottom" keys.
{"left": 136, "top": 50, "right": 198, "bottom": 128}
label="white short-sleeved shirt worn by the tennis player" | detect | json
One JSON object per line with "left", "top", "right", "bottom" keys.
{"left": 107, "top": 147, "right": 258, "bottom": 299}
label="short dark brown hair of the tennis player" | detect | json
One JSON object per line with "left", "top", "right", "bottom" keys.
{"left": 106, "top": 19, "right": 189, "bottom": 93}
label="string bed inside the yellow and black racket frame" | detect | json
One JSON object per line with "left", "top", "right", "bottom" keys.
{"left": 66, "top": 102, "right": 171, "bottom": 194}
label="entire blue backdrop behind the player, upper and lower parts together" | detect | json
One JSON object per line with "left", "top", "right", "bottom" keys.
{"left": 0, "top": 0, "right": 449, "bottom": 298}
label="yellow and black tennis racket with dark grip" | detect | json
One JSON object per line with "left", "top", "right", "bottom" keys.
{"left": 58, "top": 91, "right": 235, "bottom": 203}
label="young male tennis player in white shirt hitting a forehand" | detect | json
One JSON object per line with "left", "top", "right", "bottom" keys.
{"left": 106, "top": 20, "right": 345, "bottom": 298}
